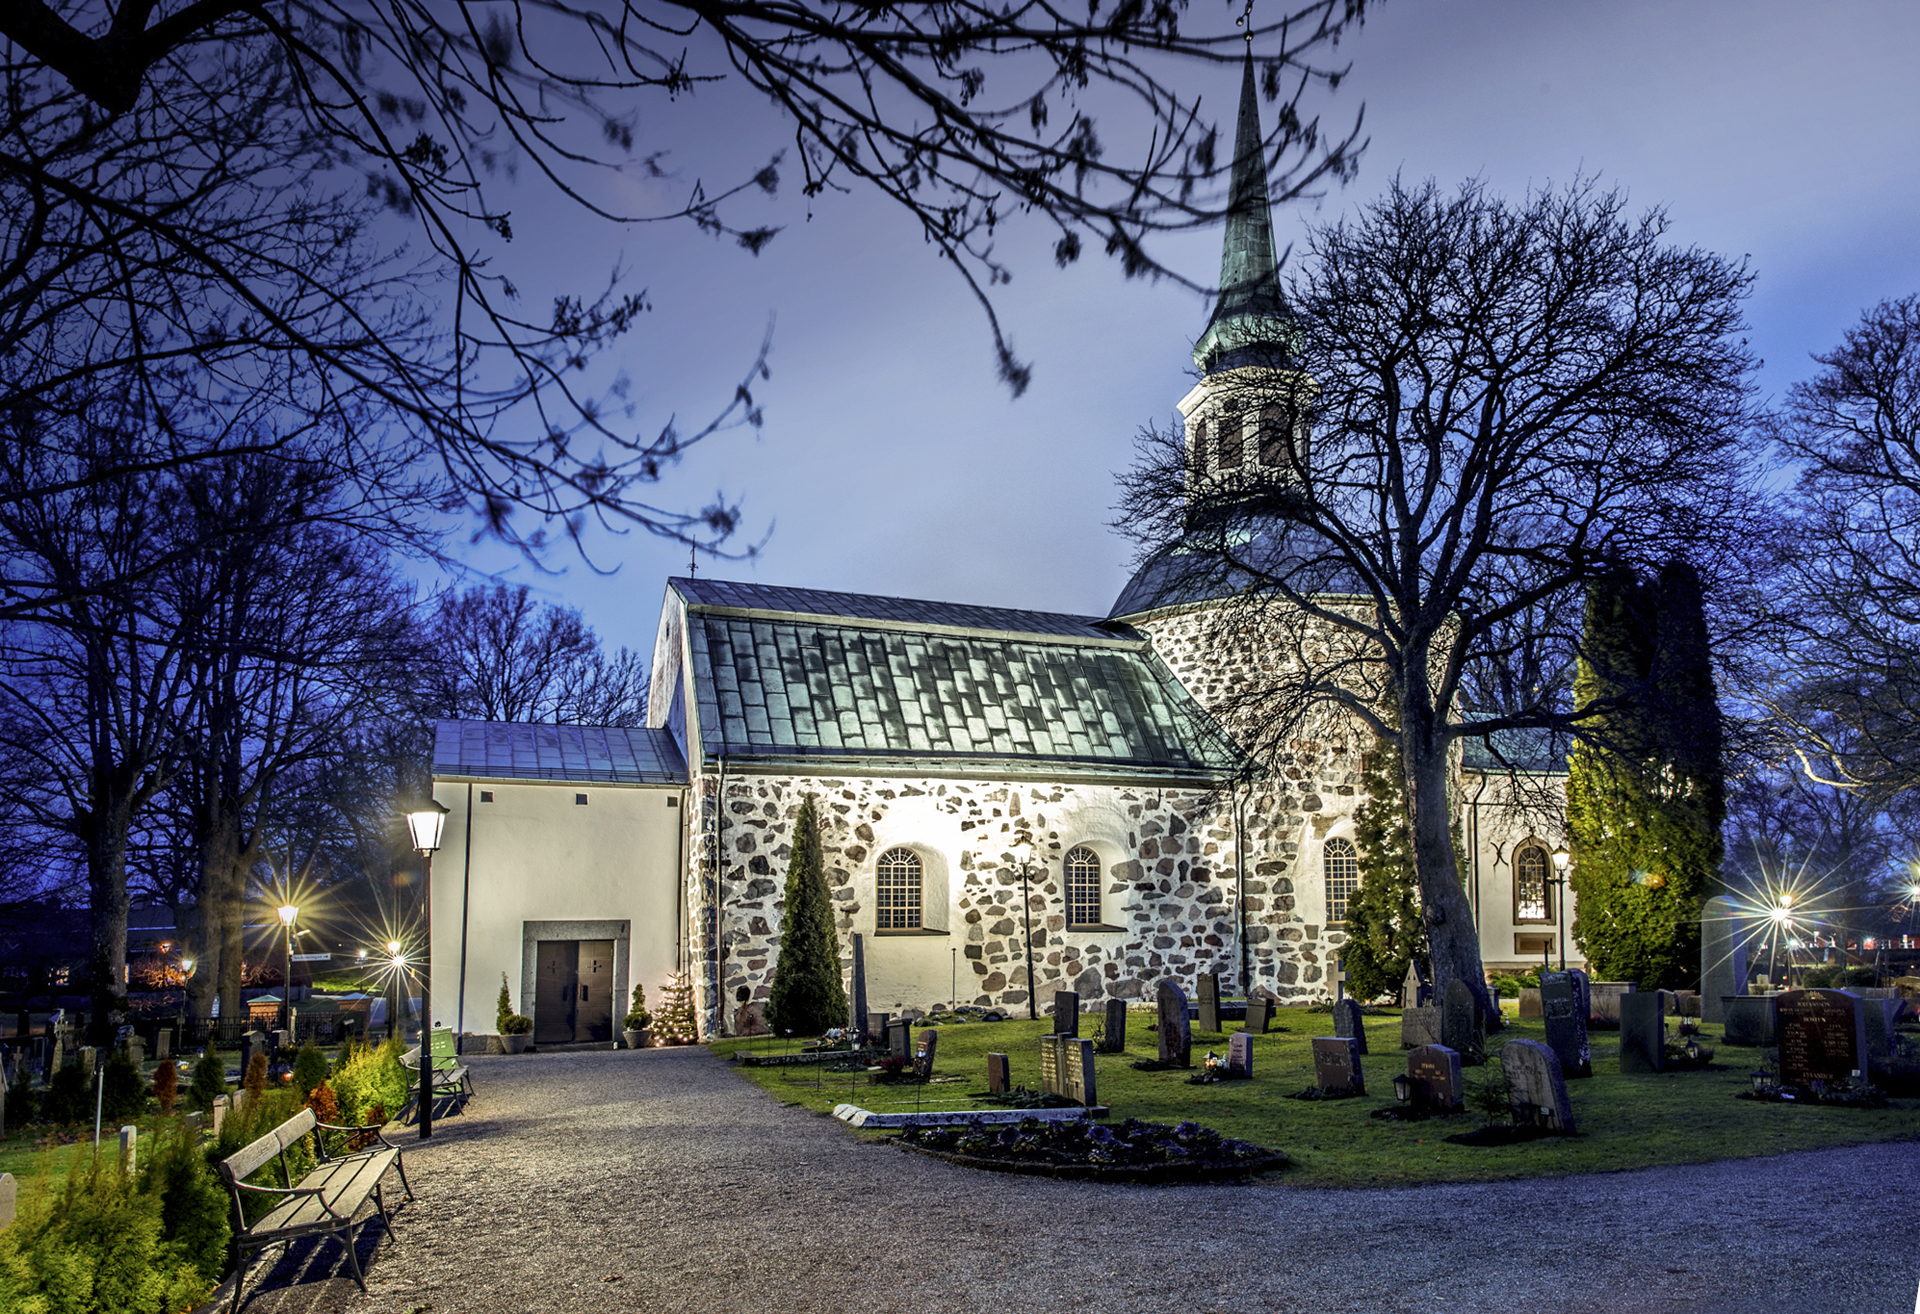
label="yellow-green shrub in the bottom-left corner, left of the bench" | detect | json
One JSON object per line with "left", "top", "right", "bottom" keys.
{"left": 0, "top": 1156, "right": 211, "bottom": 1314}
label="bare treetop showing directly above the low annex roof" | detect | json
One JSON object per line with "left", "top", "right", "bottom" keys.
{"left": 432, "top": 584, "right": 649, "bottom": 726}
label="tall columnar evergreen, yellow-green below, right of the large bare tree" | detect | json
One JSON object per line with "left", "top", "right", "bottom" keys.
{"left": 1567, "top": 563, "right": 1726, "bottom": 989}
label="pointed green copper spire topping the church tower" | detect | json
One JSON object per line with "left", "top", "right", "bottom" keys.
{"left": 1194, "top": 50, "right": 1296, "bottom": 375}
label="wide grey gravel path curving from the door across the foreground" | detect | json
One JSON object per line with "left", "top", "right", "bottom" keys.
{"left": 244, "top": 1049, "right": 1920, "bottom": 1314}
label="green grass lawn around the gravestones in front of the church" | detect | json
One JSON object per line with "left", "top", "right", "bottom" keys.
{"left": 710, "top": 1009, "right": 1920, "bottom": 1187}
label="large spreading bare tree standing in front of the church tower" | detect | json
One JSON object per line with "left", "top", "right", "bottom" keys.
{"left": 1121, "top": 174, "right": 1751, "bottom": 1012}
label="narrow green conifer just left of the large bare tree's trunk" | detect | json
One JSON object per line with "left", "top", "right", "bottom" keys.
{"left": 1340, "top": 740, "right": 1427, "bottom": 999}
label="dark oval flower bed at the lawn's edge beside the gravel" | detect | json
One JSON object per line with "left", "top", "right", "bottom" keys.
{"left": 893, "top": 1118, "right": 1288, "bottom": 1183}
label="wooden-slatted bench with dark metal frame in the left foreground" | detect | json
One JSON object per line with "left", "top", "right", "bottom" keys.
{"left": 219, "top": 1108, "right": 413, "bottom": 1310}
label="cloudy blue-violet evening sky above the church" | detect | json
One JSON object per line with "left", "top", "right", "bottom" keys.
{"left": 441, "top": 0, "right": 1920, "bottom": 651}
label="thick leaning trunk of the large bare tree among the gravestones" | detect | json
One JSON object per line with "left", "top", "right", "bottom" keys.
{"left": 1400, "top": 705, "right": 1500, "bottom": 1032}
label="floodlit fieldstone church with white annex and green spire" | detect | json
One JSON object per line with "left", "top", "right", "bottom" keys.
{"left": 432, "top": 65, "right": 1580, "bottom": 1043}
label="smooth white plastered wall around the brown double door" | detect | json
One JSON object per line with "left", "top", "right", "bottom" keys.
{"left": 432, "top": 780, "right": 685, "bottom": 1035}
